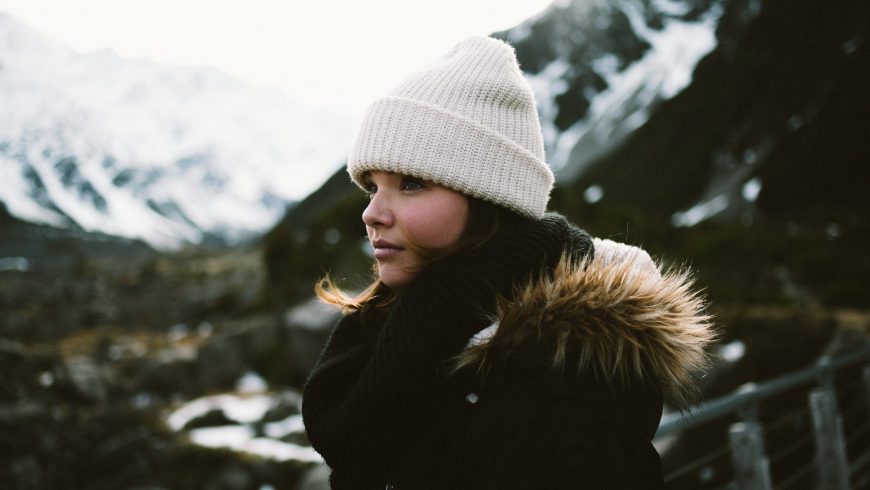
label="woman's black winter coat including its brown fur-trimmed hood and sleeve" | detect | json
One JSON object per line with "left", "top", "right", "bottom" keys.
{"left": 303, "top": 215, "right": 711, "bottom": 489}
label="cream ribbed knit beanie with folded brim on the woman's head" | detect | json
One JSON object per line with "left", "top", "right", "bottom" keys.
{"left": 347, "top": 36, "right": 553, "bottom": 218}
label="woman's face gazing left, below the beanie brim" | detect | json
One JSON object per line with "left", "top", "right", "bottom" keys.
{"left": 362, "top": 170, "right": 468, "bottom": 288}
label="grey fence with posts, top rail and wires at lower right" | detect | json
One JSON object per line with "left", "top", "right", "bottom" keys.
{"left": 656, "top": 347, "right": 870, "bottom": 490}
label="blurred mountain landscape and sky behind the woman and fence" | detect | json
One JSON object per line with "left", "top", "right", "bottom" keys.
{"left": 0, "top": 0, "right": 870, "bottom": 489}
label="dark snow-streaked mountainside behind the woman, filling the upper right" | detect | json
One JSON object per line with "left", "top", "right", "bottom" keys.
{"left": 265, "top": 0, "right": 870, "bottom": 306}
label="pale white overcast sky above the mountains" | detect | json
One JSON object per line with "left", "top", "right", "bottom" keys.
{"left": 0, "top": 0, "right": 552, "bottom": 119}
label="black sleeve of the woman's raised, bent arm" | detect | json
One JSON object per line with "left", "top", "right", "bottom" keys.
{"left": 302, "top": 297, "right": 498, "bottom": 488}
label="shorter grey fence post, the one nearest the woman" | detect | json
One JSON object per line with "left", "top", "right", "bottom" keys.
{"left": 729, "top": 422, "right": 772, "bottom": 490}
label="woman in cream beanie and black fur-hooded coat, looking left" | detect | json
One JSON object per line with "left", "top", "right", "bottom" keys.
{"left": 303, "top": 37, "right": 712, "bottom": 489}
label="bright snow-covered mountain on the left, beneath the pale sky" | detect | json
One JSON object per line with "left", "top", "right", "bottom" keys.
{"left": 0, "top": 13, "right": 353, "bottom": 248}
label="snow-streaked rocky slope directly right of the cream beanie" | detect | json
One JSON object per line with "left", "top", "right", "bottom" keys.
{"left": 502, "top": 0, "right": 722, "bottom": 181}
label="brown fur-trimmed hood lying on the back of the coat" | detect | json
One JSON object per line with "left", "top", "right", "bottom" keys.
{"left": 457, "top": 239, "right": 715, "bottom": 406}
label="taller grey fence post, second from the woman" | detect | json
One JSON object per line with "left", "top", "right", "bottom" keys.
{"left": 810, "top": 388, "right": 849, "bottom": 490}
